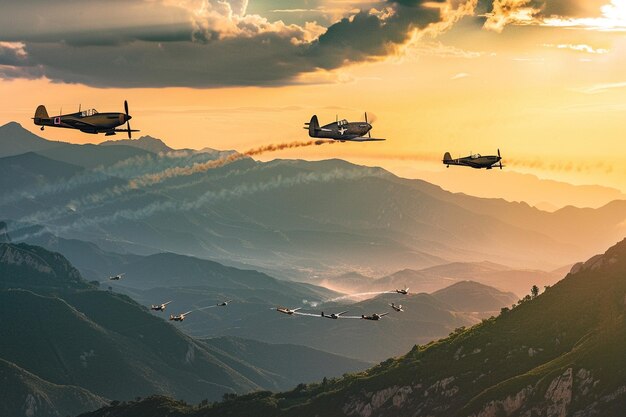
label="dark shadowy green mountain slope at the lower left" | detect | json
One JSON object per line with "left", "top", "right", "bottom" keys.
{"left": 0, "top": 243, "right": 367, "bottom": 416}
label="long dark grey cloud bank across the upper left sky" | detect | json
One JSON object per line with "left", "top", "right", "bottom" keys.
{"left": 0, "top": 0, "right": 458, "bottom": 87}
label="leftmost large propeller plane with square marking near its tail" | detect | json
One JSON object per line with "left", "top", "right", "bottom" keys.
{"left": 33, "top": 101, "right": 139, "bottom": 139}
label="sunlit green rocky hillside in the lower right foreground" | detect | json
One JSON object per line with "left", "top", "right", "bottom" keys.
{"left": 80, "top": 240, "right": 626, "bottom": 417}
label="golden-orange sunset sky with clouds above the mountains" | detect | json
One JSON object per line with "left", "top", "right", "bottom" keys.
{"left": 0, "top": 0, "right": 626, "bottom": 200}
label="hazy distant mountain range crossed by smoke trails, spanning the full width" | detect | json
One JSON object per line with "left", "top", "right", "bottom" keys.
{"left": 0, "top": 120, "right": 626, "bottom": 281}
